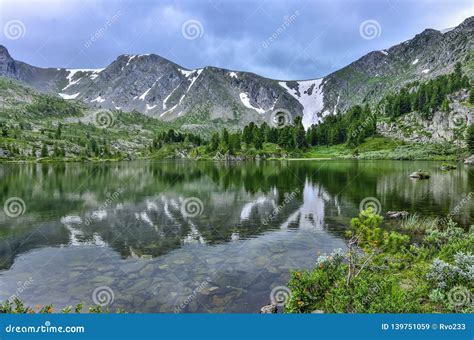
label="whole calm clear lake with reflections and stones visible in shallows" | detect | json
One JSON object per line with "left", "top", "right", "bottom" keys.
{"left": 0, "top": 161, "right": 474, "bottom": 313}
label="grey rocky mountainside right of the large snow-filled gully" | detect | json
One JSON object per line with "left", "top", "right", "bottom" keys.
{"left": 323, "top": 17, "right": 474, "bottom": 110}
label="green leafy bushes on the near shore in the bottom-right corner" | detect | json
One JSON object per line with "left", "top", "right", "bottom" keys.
{"left": 285, "top": 210, "right": 474, "bottom": 313}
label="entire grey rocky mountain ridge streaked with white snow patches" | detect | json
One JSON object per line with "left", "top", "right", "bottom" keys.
{"left": 0, "top": 17, "right": 474, "bottom": 128}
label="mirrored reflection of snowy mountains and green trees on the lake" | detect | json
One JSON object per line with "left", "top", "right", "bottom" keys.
{"left": 0, "top": 161, "right": 474, "bottom": 269}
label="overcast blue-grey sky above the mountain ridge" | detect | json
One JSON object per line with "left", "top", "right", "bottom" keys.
{"left": 0, "top": 0, "right": 474, "bottom": 79}
